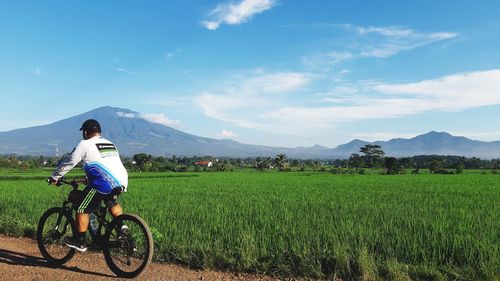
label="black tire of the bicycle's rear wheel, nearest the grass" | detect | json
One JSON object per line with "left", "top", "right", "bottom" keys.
{"left": 103, "top": 214, "right": 154, "bottom": 278}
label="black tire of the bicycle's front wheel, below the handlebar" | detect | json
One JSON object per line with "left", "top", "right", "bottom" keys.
{"left": 36, "top": 207, "right": 76, "bottom": 266}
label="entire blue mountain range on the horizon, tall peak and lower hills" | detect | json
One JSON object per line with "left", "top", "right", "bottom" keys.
{"left": 0, "top": 106, "right": 500, "bottom": 159}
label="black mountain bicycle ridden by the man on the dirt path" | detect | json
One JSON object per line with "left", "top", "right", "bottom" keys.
{"left": 36, "top": 179, "right": 154, "bottom": 278}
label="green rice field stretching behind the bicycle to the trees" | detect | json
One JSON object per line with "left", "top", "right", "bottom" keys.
{"left": 0, "top": 171, "right": 500, "bottom": 280}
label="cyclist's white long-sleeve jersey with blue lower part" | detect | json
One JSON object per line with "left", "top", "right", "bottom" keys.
{"left": 52, "top": 136, "right": 128, "bottom": 194}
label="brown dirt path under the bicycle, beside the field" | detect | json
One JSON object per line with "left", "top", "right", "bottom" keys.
{"left": 0, "top": 236, "right": 282, "bottom": 281}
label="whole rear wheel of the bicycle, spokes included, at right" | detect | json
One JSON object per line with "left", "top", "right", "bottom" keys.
{"left": 103, "top": 214, "right": 154, "bottom": 278}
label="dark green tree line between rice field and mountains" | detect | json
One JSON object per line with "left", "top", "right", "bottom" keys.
{"left": 0, "top": 144, "right": 500, "bottom": 174}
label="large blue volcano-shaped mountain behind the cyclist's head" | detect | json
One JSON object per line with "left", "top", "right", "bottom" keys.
{"left": 0, "top": 106, "right": 329, "bottom": 158}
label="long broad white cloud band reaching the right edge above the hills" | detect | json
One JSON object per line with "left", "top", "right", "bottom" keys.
{"left": 198, "top": 69, "right": 500, "bottom": 134}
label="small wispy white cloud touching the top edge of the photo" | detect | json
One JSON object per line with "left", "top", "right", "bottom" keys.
{"left": 202, "top": 0, "right": 276, "bottom": 30}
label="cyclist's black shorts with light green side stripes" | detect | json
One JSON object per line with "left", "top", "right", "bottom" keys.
{"left": 69, "top": 186, "right": 118, "bottom": 214}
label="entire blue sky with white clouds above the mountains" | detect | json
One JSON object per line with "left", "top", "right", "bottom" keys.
{"left": 0, "top": 0, "right": 500, "bottom": 147}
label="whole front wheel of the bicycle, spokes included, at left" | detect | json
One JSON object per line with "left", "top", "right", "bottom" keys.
{"left": 36, "top": 207, "right": 76, "bottom": 265}
